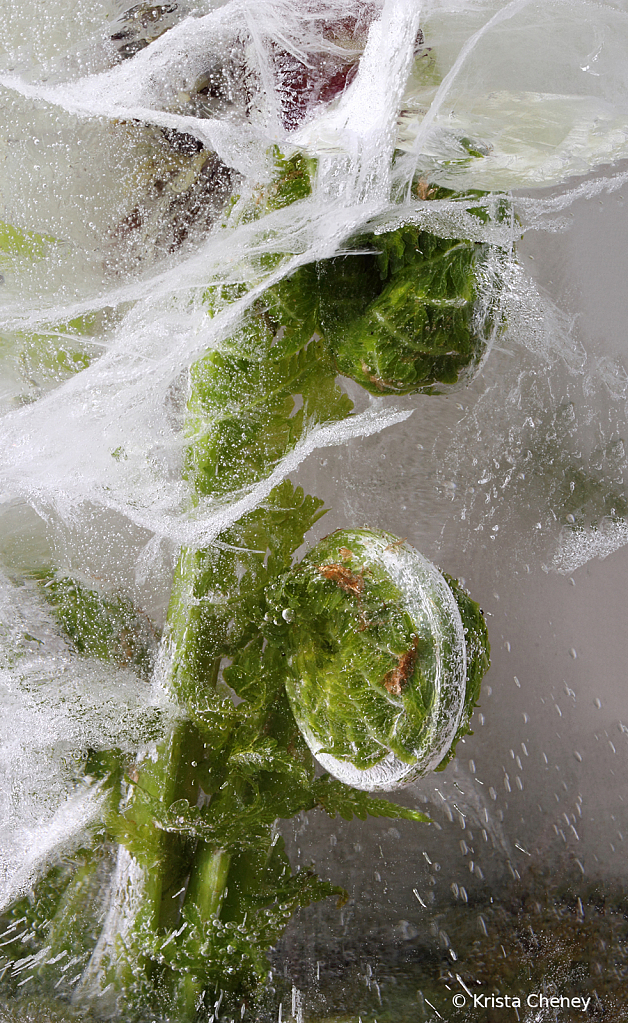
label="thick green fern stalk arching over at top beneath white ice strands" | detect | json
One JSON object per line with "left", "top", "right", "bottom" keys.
{"left": 126, "top": 169, "right": 497, "bottom": 1019}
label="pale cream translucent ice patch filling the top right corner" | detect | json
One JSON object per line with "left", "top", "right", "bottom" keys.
{"left": 401, "top": 0, "right": 628, "bottom": 188}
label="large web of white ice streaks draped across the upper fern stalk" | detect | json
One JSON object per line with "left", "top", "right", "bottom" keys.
{"left": 2, "top": 3, "right": 435, "bottom": 560}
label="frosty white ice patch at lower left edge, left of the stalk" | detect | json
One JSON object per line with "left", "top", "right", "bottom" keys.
{"left": 0, "top": 576, "right": 172, "bottom": 905}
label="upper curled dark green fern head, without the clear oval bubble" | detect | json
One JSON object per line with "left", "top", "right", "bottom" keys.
{"left": 320, "top": 227, "right": 486, "bottom": 394}
